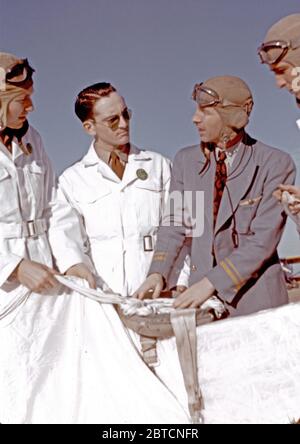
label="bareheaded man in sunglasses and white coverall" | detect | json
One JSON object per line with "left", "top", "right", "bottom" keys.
{"left": 50, "top": 82, "right": 189, "bottom": 296}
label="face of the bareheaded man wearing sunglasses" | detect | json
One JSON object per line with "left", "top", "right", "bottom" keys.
{"left": 84, "top": 92, "right": 129, "bottom": 149}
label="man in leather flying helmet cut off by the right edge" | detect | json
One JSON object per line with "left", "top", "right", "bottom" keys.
{"left": 258, "top": 14, "right": 300, "bottom": 231}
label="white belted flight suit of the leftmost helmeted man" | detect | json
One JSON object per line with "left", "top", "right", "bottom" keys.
{"left": 0, "top": 127, "right": 55, "bottom": 294}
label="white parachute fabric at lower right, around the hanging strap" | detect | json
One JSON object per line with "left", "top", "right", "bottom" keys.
{"left": 156, "top": 303, "right": 300, "bottom": 424}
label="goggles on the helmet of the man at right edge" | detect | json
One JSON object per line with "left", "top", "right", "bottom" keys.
{"left": 257, "top": 38, "right": 300, "bottom": 65}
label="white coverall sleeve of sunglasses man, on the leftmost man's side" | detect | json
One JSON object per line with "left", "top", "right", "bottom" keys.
{"left": 49, "top": 175, "right": 94, "bottom": 273}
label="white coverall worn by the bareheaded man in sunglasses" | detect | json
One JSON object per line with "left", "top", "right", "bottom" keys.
{"left": 50, "top": 143, "right": 189, "bottom": 296}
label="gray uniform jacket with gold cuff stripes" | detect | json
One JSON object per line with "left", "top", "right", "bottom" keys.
{"left": 149, "top": 138, "right": 295, "bottom": 316}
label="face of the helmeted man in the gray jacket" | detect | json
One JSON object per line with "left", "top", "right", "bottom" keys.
{"left": 193, "top": 105, "right": 224, "bottom": 144}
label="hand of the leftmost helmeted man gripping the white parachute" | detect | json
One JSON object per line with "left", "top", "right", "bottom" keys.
{"left": 13, "top": 259, "right": 59, "bottom": 293}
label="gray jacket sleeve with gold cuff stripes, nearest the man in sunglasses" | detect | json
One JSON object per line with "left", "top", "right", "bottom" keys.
{"left": 148, "top": 153, "right": 186, "bottom": 281}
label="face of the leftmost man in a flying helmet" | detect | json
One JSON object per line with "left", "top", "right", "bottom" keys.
{"left": 6, "top": 87, "right": 34, "bottom": 129}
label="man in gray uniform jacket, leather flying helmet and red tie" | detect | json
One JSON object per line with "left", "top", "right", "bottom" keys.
{"left": 135, "top": 76, "right": 295, "bottom": 316}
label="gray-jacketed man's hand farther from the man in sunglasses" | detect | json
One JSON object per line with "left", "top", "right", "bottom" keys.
{"left": 173, "top": 277, "right": 215, "bottom": 308}
